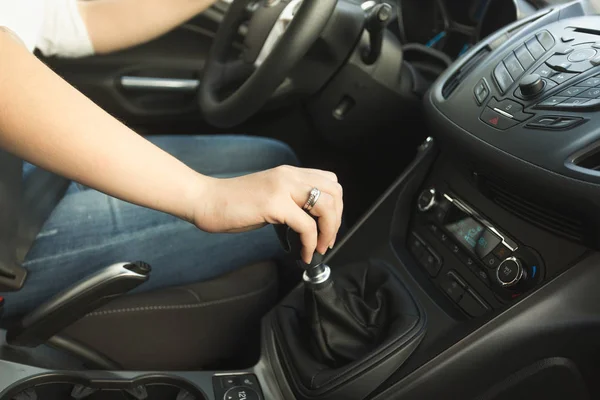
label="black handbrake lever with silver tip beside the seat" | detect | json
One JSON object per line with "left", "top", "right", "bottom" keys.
{"left": 6, "top": 262, "right": 151, "bottom": 347}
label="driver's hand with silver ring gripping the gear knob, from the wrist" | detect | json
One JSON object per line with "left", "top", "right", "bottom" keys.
{"left": 192, "top": 165, "right": 343, "bottom": 263}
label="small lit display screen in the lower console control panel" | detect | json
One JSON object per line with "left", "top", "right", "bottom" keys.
{"left": 444, "top": 208, "right": 502, "bottom": 258}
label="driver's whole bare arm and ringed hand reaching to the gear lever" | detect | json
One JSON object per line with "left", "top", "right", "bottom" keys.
{"left": 0, "top": 28, "right": 342, "bottom": 261}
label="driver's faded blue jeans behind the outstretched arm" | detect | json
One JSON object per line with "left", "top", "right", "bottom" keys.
{"left": 0, "top": 135, "right": 298, "bottom": 317}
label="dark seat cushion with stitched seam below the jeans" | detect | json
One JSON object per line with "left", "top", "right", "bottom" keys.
{"left": 63, "top": 262, "right": 278, "bottom": 370}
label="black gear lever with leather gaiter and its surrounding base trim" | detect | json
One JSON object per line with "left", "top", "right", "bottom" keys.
{"left": 274, "top": 227, "right": 425, "bottom": 399}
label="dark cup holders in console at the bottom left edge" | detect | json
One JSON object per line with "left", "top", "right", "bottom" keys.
{"left": 0, "top": 374, "right": 208, "bottom": 400}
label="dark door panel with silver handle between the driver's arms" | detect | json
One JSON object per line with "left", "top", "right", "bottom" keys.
{"left": 42, "top": 2, "right": 227, "bottom": 134}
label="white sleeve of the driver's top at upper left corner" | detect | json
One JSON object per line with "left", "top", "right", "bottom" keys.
{"left": 0, "top": 0, "right": 94, "bottom": 57}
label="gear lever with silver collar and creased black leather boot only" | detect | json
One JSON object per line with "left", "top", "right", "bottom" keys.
{"left": 275, "top": 225, "right": 404, "bottom": 366}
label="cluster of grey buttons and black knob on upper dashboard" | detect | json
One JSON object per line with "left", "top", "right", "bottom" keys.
{"left": 480, "top": 29, "right": 600, "bottom": 130}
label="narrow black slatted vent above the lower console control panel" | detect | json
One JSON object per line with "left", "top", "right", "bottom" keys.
{"left": 478, "top": 177, "right": 587, "bottom": 243}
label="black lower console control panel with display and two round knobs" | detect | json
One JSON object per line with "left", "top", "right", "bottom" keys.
{"left": 408, "top": 187, "right": 544, "bottom": 316}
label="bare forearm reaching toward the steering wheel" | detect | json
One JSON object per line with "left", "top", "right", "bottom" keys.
{"left": 78, "top": 0, "right": 216, "bottom": 53}
